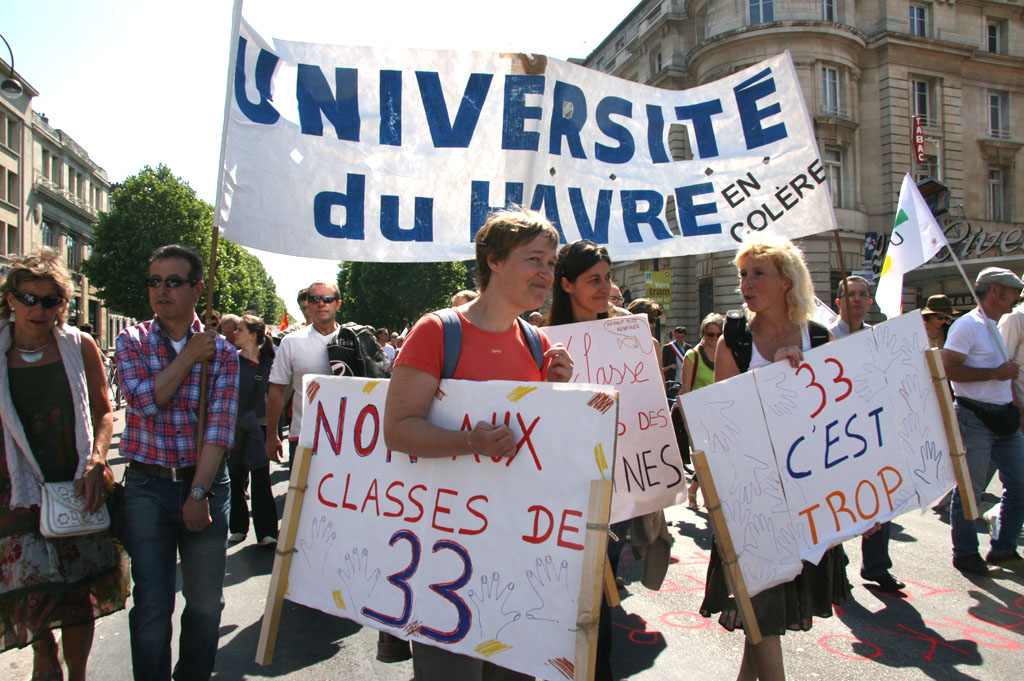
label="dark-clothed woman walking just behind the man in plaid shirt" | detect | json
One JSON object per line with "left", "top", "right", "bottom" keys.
{"left": 227, "top": 314, "right": 278, "bottom": 546}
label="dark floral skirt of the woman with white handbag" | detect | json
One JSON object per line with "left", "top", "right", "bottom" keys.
{"left": 0, "top": 499, "right": 129, "bottom": 652}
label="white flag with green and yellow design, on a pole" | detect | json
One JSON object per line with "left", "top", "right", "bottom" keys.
{"left": 874, "top": 173, "right": 948, "bottom": 320}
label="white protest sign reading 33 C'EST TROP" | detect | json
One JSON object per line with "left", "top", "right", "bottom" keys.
{"left": 681, "top": 312, "right": 954, "bottom": 595}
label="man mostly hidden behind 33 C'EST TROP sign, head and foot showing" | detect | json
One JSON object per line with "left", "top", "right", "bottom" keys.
{"left": 828, "top": 274, "right": 906, "bottom": 594}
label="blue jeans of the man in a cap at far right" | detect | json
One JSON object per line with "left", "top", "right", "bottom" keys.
{"left": 949, "top": 403, "right": 1024, "bottom": 558}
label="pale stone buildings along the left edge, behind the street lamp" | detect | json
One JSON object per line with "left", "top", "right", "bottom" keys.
{"left": 0, "top": 58, "right": 133, "bottom": 350}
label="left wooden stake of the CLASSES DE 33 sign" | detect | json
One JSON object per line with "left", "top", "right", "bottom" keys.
{"left": 256, "top": 446, "right": 312, "bottom": 666}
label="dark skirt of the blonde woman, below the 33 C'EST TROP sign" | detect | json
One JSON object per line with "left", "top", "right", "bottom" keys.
{"left": 700, "top": 541, "right": 850, "bottom": 636}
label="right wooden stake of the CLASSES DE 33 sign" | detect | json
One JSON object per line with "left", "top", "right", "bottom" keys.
{"left": 572, "top": 480, "right": 618, "bottom": 681}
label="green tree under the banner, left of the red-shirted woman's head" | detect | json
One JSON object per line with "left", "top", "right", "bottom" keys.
{"left": 338, "top": 262, "right": 466, "bottom": 330}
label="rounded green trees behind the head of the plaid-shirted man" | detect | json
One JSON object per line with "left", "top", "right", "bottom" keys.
{"left": 83, "top": 165, "right": 285, "bottom": 324}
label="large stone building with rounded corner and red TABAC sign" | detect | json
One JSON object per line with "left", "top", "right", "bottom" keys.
{"left": 580, "top": 0, "right": 1024, "bottom": 333}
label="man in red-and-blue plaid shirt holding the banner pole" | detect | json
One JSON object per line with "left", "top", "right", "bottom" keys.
{"left": 117, "top": 245, "right": 239, "bottom": 681}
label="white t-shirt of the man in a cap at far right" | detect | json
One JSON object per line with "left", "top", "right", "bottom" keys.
{"left": 943, "top": 307, "right": 1013, "bottom": 405}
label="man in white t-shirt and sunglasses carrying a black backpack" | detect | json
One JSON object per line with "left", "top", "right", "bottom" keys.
{"left": 266, "top": 282, "right": 341, "bottom": 462}
